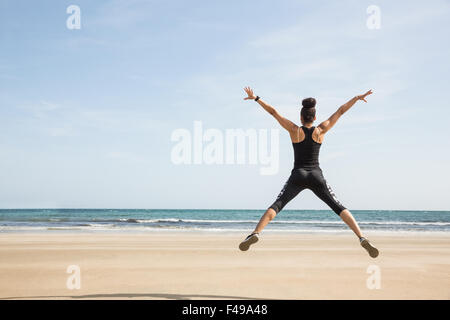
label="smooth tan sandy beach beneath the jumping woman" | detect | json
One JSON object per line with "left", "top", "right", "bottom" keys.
{"left": 0, "top": 232, "right": 450, "bottom": 299}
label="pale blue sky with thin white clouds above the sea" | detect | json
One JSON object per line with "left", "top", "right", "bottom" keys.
{"left": 0, "top": 0, "right": 450, "bottom": 210}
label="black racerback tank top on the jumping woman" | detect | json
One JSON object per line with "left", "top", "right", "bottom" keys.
{"left": 292, "top": 126, "right": 322, "bottom": 169}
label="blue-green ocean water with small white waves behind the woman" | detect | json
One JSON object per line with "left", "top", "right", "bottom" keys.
{"left": 0, "top": 209, "right": 450, "bottom": 233}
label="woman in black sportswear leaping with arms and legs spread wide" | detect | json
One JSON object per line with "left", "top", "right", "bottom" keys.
{"left": 239, "top": 87, "right": 378, "bottom": 258}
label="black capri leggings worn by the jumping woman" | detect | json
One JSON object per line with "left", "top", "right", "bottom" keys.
{"left": 269, "top": 168, "right": 346, "bottom": 215}
